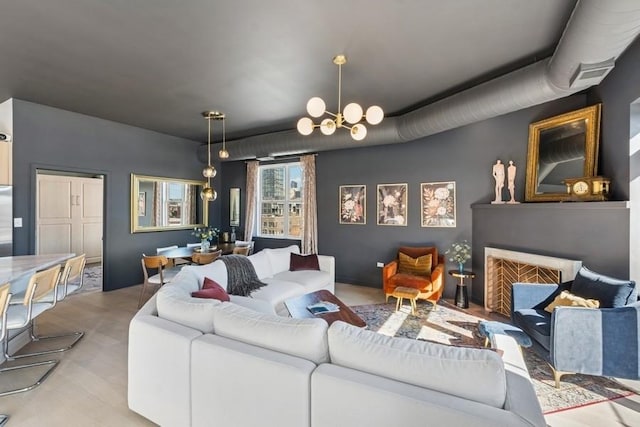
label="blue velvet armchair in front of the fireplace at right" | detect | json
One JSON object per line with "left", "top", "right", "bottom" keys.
{"left": 511, "top": 267, "right": 640, "bottom": 387}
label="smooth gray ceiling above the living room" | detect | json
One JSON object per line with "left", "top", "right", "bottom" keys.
{"left": 0, "top": 0, "right": 576, "bottom": 141}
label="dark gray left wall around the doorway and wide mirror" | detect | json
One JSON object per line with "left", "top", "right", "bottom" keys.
{"left": 13, "top": 100, "right": 220, "bottom": 290}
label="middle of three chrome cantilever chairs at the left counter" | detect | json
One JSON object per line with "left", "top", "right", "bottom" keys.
{"left": 4, "top": 264, "right": 61, "bottom": 360}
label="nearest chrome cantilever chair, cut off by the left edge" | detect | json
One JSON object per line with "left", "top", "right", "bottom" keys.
{"left": 0, "top": 283, "right": 58, "bottom": 398}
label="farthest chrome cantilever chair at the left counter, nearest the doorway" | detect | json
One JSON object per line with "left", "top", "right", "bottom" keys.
{"left": 26, "top": 254, "right": 86, "bottom": 354}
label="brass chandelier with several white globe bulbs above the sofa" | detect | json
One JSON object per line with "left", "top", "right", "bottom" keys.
{"left": 297, "top": 55, "right": 384, "bottom": 141}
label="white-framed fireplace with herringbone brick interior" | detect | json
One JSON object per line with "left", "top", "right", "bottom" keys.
{"left": 484, "top": 247, "right": 582, "bottom": 317}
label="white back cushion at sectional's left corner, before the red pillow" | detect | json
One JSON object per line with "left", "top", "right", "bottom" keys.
{"left": 156, "top": 284, "right": 222, "bottom": 333}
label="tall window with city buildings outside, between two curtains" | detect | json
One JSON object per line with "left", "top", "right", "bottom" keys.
{"left": 258, "top": 163, "right": 303, "bottom": 239}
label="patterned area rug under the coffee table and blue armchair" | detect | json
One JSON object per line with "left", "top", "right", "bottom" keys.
{"left": 352, "top": 301, "right": 634, "bottom": 414}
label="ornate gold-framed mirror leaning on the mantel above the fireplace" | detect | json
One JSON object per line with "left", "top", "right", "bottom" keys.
{"left": 525, "top": 104, "right": 601, "bottom": 202}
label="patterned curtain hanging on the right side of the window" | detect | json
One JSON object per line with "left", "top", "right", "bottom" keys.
{"left": 300, "top": 154, "right": 318, "bottom": 254}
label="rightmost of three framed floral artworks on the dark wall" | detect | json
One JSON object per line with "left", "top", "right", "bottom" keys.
{"left": 420, "top": 181, "right": 456, "bottom": 227}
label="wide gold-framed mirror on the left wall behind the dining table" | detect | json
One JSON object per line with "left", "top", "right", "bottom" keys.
{"left": 131, "top": 173, "right": 208, "bottom": 233}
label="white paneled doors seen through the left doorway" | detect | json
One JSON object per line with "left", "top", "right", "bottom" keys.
{"left": 36, "top": 173, "right": 103, "bottom": 263}
